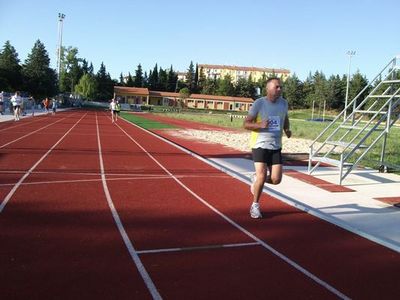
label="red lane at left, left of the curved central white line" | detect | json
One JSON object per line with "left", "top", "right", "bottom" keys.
{"left": 0, "top": 114, "right": 154, "bottom": 299}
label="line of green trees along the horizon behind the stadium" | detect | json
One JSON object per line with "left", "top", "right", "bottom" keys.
{"left": 0, "top": 40, "right": 390, "bottom": 110}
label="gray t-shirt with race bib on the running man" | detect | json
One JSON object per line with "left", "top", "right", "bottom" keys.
{"left": 249, "top": 97, "right": 288, "bottom": 150}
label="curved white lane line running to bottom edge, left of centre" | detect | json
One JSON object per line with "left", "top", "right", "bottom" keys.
{"left": 96, "top": 113, "right": 162, "bottom": 299}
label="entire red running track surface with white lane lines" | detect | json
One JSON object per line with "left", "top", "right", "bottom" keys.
{"left": 0, "top": 111, "right": 400, "bottom": 299}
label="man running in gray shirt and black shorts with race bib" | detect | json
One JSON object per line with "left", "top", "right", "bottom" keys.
{"left": 243, "top": 77, "right": 292, "bottom": 219}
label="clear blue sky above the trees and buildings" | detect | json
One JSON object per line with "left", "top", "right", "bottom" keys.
{"left": 0, "top": 0, "right": 400, "bottom": 80}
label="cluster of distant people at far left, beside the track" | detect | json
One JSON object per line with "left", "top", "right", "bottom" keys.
{"left": 0, "top": 91, "right": 57, "bottom": 121}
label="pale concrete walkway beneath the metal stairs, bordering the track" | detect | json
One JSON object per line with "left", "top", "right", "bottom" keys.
{"left": 209, "top": 158, "right": 400, "bottom": 253}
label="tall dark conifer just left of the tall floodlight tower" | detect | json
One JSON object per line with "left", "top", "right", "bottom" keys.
{"left": 22, "top": 40, "right": 58, "bottom": 99}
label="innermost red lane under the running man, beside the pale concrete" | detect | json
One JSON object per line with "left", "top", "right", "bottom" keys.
{"left": 118, "top": 111, "right": 400, "bottom": 299}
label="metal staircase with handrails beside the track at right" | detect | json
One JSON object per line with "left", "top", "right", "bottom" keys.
{"left": 308, "top": 56, "right": 400, "bottom": 184}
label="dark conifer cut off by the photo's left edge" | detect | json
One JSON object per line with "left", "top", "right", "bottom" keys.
{"left": 0, "top": 41, "right": 22, "bottom": 91}
